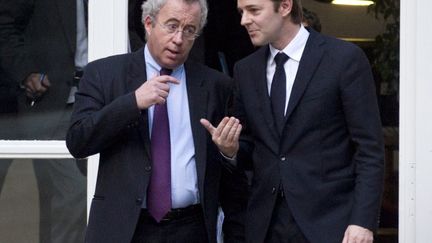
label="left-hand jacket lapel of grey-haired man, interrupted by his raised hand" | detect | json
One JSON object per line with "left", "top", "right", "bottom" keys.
{"left": 126, "top": 48, "right": 151, "bottom": 158}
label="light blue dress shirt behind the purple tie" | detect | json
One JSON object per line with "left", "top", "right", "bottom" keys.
{"left": 143, "top": 45, "right": 199, "bottom": 208}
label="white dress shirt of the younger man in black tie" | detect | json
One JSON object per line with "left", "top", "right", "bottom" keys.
{"left": 267, "top": 25, "right": 309, "bottom": 113}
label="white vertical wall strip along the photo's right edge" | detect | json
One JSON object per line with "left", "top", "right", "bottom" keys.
{"left": 399, "top": 0, "right": 432, "bottom": 243}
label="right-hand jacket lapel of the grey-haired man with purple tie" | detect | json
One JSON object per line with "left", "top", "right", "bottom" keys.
{"left": 185, "top": 62, "right": 208, "bottom": 199}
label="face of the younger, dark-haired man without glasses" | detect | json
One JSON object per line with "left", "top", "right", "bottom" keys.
{"left": 237, "top": 0, "right": 284, "bottom": 46}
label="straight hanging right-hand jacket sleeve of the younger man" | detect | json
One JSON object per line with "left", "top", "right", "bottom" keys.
{"left": 340, "top": 45, "right": 384, "bottom": 230}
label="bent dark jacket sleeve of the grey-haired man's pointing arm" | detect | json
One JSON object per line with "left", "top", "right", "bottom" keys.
{"left": 66, "top": 60, "right": 141, "bottom": 158}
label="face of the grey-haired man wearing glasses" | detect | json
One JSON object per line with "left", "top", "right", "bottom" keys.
{"left": 144, "top": 0, "right": 201, "bottom": 69}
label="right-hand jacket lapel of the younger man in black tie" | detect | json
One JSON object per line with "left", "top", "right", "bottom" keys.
{"left": 285, "top": 30, "right": 324, "bottom": 121}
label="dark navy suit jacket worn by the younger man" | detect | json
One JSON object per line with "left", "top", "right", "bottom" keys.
{"left": 234, "top": 30, "right": 384, "bottom": 243}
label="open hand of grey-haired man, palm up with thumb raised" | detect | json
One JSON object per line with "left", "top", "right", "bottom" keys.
{"left": 200, "top": 117, "right": 242, "bottom": 158}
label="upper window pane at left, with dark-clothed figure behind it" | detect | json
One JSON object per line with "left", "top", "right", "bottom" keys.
{"left": 0, "top": 0, "right": 87, "bottom": 140}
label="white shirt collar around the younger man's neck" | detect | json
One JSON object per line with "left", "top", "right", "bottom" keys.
{"left": 269, "top": 25, "right": 309, "bottom": 62}
